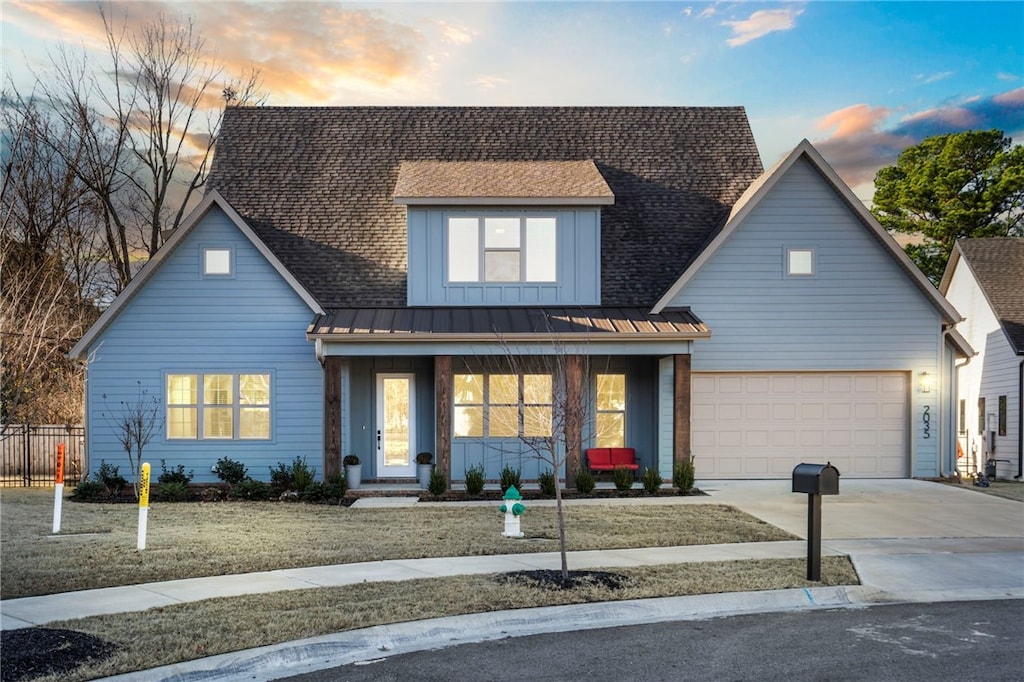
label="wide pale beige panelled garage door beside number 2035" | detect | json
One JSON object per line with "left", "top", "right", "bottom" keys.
{"left": 691, "top": 372, "right": 909, "bottom": 478}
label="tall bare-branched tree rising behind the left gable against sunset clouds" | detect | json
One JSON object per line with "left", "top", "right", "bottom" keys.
{"left": 37, "top": 6, "right": 262, "bottom": 292}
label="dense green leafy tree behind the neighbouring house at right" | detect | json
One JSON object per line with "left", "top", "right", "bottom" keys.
{"left": 871, "top": 130, "right": 1024, "bottom": 284}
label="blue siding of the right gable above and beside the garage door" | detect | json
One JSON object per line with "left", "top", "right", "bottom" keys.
{"left": 670, "top": 159, "right": 942, "bottom": 476}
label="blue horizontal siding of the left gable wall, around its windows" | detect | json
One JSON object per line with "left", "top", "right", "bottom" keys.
{"left": 86, "top": 207, "right": 324, "bottom": 482}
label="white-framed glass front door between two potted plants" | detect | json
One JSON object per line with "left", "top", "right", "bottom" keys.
{"left": 377, "top": 374, "right": 416, "bottom": 478}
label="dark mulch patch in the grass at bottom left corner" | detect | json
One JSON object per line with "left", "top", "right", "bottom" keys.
{"left": 0, "top": 628, "right": 117, "bottom": 682}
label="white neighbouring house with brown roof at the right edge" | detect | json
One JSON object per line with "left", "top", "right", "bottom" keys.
{"left": 939, "top": 238, "right": 1024, "bottom": 480}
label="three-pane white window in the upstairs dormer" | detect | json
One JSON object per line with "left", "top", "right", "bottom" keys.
{"left": 447, "top": 216, "right": 558, "bottom": 283}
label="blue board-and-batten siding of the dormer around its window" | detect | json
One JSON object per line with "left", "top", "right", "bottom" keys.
{"left": 408, "top": 207, "right": 601, "bottom": 305}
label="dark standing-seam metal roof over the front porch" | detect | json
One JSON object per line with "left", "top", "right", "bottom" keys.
{"left": 306, "top": 307, "right": 711, "bottom": 342}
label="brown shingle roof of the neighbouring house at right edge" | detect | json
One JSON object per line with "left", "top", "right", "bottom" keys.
{"left": 956, "top": 237, "right": 1024, "bottom": 355}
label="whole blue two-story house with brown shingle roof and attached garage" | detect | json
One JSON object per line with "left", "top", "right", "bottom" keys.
{"left": 73, "top": 108, "right": 967, "bottom": 485}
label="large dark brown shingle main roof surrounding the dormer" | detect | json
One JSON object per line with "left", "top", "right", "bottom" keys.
{"left": 208, "top": 106, "right": 762, "bottom": 308}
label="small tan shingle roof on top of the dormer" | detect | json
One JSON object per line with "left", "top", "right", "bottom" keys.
{"left": 394, "top": 160, "right": 615, "bottom": 205}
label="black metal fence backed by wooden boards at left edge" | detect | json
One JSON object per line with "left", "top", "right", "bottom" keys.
{"left": 0, "top": 424, "right": 85, "bottom": 487}
